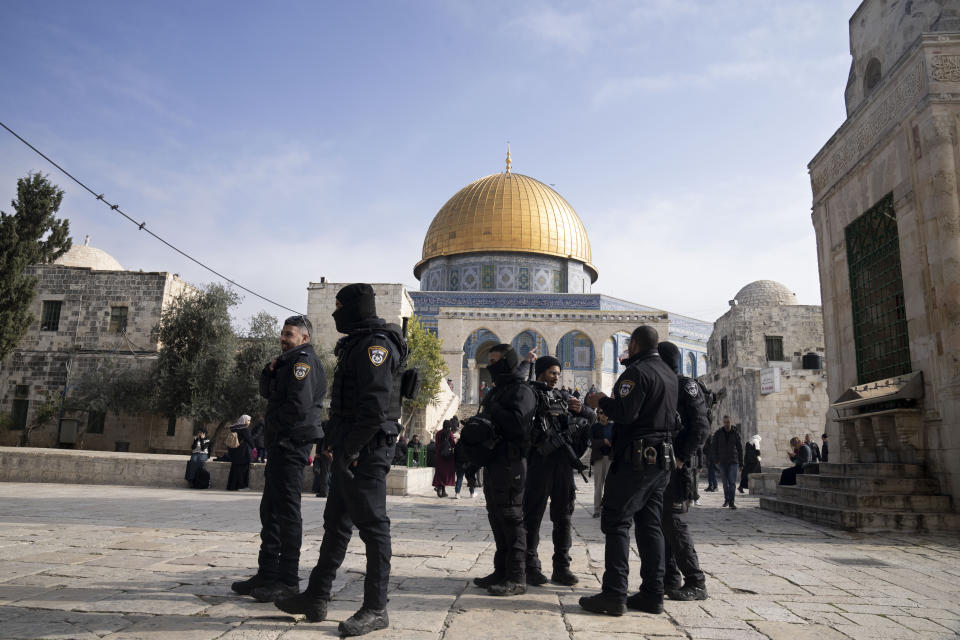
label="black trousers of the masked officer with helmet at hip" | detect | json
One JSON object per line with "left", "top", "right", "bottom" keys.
{"left": 483, "top": 453, "right": 527, "bottom": 584}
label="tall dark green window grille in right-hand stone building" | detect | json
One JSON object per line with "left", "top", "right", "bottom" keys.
{"left": 845, "top": 193, "right": 910, "bottom": 384}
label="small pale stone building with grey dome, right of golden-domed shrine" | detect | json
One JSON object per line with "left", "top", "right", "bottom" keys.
{"left": 700, "top": 280, "right": 829, "bottom": 466}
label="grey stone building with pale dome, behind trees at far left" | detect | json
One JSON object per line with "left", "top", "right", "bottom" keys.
{"left": 0, "top": 236, "right": 191, "bottom": 451}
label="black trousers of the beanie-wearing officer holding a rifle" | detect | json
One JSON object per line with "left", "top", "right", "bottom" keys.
{"left": 523, "top": 450, "right": 577, "bottom": 572}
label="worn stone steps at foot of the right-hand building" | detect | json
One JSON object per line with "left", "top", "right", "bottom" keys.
{"left": 750, "top": 462, "right": 960, "bottom": 532}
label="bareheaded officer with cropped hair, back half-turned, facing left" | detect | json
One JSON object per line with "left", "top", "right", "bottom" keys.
{"left": 580, "top": 325, "right": 677, "bottom": 616}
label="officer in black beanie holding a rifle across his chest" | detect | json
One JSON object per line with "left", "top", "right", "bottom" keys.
{"left": 523, "top": 356, "right": 596, "bottom": 586}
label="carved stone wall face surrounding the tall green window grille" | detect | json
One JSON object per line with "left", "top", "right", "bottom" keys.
{"left": 810, "top": 27, "right": 960, "bottom": 509}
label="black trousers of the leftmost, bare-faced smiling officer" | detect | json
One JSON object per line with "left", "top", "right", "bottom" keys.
{"left": 257, "top": 439, "right": 313, "bottom": 585}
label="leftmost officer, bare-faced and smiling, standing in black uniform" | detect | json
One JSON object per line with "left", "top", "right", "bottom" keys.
{"left": 231, "top": 316, "right": 327, "bottom": 602}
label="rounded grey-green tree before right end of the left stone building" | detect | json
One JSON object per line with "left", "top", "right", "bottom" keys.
{"left": 154, "top": 284, "right": 239, "bottom": 424}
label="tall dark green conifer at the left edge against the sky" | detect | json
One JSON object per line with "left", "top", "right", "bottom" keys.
{"left": 0, "top": 173, "right": 70, "bottom": 360}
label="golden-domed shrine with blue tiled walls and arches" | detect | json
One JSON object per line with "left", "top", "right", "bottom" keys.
{"left": 410, "top": 151, "right": 711, "bottom": 404}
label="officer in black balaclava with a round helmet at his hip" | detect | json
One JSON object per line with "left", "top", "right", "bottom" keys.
{"left": 473, "top": 344, "right": 537, "bottom": 596}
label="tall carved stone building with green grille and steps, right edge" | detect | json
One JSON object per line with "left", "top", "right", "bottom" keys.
{"left": 760, "top": 0, "right": 960, "bottom": 530}
